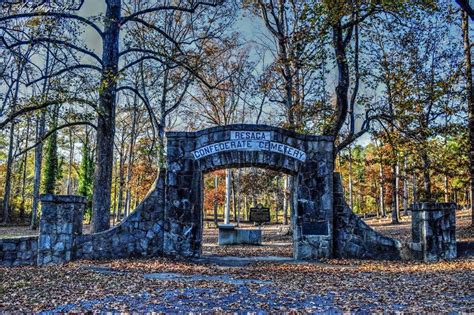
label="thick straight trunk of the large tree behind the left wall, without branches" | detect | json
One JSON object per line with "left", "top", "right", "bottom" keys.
{"left": 92, "top": 0, "right": 121, "bottom": 233}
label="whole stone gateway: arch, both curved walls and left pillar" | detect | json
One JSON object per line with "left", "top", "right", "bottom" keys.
{"left": 0, "top": 124, "right": 408, "bottom": 265}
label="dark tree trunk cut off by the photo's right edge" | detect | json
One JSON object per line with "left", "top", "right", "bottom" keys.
{"left": 461, "top": 10, "right": 474, "bottom": 225}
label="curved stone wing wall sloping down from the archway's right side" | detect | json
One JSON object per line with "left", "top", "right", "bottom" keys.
{"left": 334, "top": 173, "right": 402, "bottom": 260}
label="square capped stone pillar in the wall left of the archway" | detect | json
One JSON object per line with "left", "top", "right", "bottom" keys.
{"left": 38, "top": 194, "right": 86, "bottom": 265}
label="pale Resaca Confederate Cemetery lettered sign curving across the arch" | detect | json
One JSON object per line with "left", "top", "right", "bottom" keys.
{"left": 192, "top": 131, "right": 306, "bottom": 162}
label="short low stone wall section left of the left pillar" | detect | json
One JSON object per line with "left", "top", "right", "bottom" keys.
{"left": 0, "top": 236, "right": 38, "bottom": 266}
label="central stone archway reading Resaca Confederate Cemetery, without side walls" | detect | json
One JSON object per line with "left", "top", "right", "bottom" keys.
{"left": 164, "top": 125, "right": 334, "bottom": 259}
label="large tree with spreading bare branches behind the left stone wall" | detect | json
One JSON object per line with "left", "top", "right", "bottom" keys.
{"left": 0, "top": 0, "right": 224, "bottom": 232}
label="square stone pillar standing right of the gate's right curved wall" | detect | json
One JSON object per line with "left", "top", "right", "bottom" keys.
{"left": 410, "top": 202, "right": 457, "bottom": 262}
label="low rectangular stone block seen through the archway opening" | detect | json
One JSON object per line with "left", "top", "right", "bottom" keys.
{"left": 219, "top": 224, "right": 262, "bottom": 245}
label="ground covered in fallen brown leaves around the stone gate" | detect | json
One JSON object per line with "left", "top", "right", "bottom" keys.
{"left": 0, "top": 212, "right": 474, "bottom": 314}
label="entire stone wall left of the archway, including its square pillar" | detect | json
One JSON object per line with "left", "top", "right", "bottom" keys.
{"left": 0, "top": 170, "right": 166, "bottom": 266}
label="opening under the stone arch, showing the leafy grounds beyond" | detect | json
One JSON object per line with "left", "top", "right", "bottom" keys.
{"left": 201, "top": 167, "right": 294, "bottom": 257}
